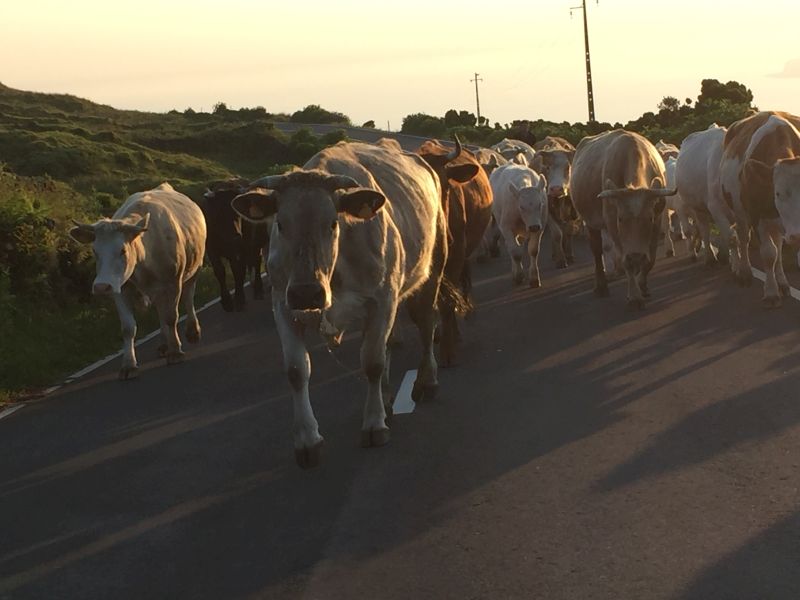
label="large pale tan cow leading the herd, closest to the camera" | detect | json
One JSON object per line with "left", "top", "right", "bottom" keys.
{"left": 233, "top": 141, "right": 447, "bottom": 468}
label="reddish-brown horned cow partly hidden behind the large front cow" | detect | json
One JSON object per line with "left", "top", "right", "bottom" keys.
{"left": 417, "top": 137, "right": 492, "bottom": 366}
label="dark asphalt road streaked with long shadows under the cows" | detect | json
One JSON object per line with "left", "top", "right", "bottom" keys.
{"left": 0, "top": 239, "right": 800, "bottom": 600}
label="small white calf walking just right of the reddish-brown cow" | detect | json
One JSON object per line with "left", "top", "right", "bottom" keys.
{"left": 489, "top": 163, "right": 565, "bottom": 287}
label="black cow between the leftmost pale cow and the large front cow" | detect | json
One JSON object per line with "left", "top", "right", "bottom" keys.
{"left": 201, "top": 179, "right": 269, "bottom": 312}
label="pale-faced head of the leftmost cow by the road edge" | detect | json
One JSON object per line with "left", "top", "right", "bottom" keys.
{"left": 69, "top": 214, "right": 150, "bottom": 295}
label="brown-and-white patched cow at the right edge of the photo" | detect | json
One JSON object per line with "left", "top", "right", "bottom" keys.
{"left": 720, "top": 112, "right": 800, "bottom": 308}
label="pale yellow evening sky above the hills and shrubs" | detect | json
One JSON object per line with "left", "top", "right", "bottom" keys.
{"left": 0, "top": 0, "right": 800, "bottom": 130}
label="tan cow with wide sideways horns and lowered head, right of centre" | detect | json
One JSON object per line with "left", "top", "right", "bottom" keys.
{"left": 571, "top": 129, "right": 675, "bottom": 308}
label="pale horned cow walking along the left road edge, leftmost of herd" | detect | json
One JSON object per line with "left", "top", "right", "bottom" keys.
{"left": 70, "top": 183, "right": 206, "bottom": 379}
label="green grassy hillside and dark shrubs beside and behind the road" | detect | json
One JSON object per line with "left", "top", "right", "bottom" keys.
{"left": 0, "top": 79, "right": 753, "bottom": 403}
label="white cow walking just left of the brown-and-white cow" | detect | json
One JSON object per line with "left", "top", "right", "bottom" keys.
{"left": 675, "top": 123, "right": 737, "bottom": 264}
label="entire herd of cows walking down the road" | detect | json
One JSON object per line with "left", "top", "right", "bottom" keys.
{"left": 70, "top": 112, "right": 800, "bottom": 467}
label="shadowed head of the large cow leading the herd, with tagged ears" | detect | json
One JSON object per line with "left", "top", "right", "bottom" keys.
{"left": 232, "top": 170, "right": 386, "bottom": 312}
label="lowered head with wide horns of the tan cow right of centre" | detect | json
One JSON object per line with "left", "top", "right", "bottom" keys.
{"left": 597, "top": 177, "right": 677, "bottom": 271}
